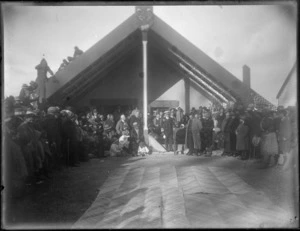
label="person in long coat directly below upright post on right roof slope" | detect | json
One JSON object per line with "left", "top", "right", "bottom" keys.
{"left": 235, "top": 116, "right": 250, "bottom": 160}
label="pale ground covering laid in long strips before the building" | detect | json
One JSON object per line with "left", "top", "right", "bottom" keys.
{"left": 73, "top": 153, "right": 293, "bottom": 229}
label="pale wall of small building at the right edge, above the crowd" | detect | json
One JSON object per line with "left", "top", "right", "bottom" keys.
{"left": 276, "top": 62, "right": 298, "bottom": 107}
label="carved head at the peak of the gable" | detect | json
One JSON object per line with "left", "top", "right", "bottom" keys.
{"left": 135, "top": 6, "right": 154, "bottom": 31}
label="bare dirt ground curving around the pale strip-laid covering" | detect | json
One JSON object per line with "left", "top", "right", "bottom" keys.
{"left": 2, "top": 154, "right": 299, "bottom": 229}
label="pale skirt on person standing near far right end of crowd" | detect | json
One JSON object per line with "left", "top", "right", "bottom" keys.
{"left": 260, "top": 132, "right": 278, "bottom": 157}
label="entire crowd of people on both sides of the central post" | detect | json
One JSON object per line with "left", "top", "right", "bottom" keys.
{"left": 4, "top": 82, "right": 297, "bottom": 195}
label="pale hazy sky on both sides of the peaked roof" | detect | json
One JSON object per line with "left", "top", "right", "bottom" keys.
{"left": 2, "top": 1, "right": 298, "bottom": 105}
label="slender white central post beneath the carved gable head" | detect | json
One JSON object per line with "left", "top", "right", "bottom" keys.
{"left": 142, "top": 30, "right": 149, "bottom": 145}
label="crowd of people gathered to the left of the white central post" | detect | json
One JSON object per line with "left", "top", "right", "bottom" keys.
{"left": 4, "top": 94, "right": 155, "bottom": 192}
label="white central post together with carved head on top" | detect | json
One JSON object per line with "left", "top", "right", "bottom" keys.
{"left": 136, "top": 6, "right": 153, "bottom": 145}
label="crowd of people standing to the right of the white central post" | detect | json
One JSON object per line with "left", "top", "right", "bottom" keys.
{"left": 149, "top": 104, "right": 297, "bottom": 170}
